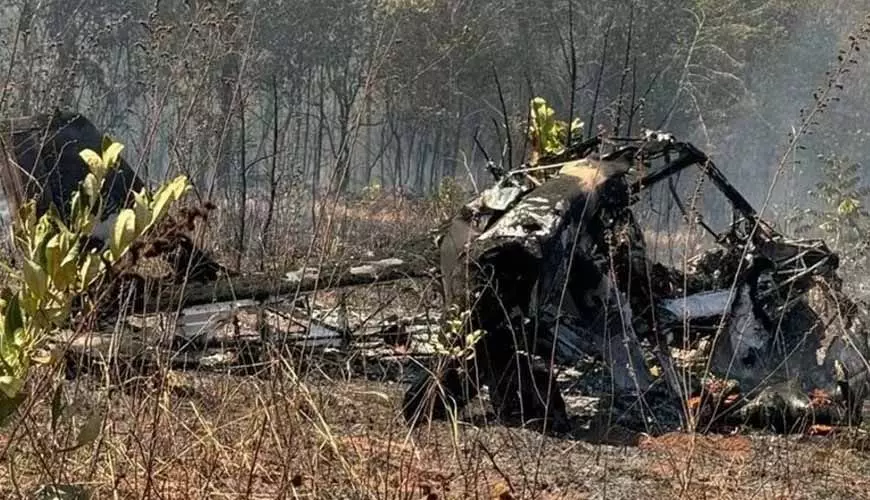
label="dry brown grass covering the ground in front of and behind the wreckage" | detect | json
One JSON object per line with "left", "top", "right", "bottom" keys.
{"left": 0, "top": 188, "right": 870, "bottom": 500}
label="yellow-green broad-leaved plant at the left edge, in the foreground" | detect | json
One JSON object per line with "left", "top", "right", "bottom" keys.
{"left": 0, "top": 137, "right": 190, "bottom": 423}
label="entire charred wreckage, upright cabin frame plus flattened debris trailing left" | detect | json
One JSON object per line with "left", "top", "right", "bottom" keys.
{"left": 3, "top": 110, "right": 870, "bottom": 438}
